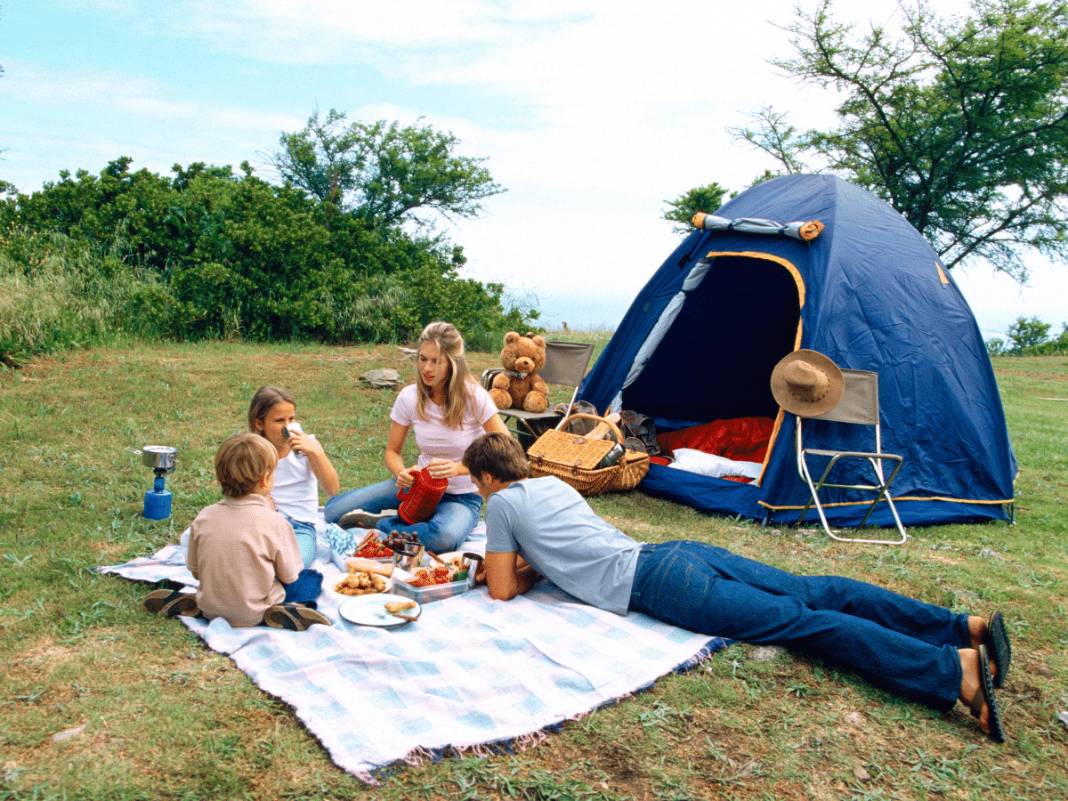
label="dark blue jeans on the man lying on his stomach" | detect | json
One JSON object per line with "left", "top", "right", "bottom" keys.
{"left": 630, "top": 540, "right": 971, "bottom": 710}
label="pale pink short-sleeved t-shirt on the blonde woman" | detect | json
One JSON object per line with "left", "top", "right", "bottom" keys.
{"left": 390, "top": 381, "right": 497, "bottom": 494}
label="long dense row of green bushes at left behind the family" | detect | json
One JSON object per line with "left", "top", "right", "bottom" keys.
{"left": 0, "top": 157, "right": 537, "bottom": 356}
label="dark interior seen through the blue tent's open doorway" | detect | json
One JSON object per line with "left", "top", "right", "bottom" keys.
{"left": 623, "top": 254, "right": 801, "bottom": 423}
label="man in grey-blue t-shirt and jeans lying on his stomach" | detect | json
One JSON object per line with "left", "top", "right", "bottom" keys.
{"left": 464, "top": 434, "right": 1011, "bottom": 742}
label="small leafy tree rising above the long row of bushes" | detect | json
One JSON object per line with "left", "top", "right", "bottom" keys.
{"left": 272, "top": 109, "right": 504, "bottom": 227}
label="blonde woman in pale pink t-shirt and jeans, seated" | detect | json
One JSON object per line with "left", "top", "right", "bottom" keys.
{"left": 324, "top": 323, "right": 507, "bottom": 552}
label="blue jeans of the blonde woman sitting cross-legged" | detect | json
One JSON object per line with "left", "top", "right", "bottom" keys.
{"left": 323, "top": 478, "right": 482, "bottom": 553}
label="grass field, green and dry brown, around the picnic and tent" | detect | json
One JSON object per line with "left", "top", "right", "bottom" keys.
{"left": 0, "top": 344, "right": 1068, "bottom": 801}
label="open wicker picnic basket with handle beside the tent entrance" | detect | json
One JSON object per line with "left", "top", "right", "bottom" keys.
{"left": 527, "top": 414, "right": 649, "bottom": 496}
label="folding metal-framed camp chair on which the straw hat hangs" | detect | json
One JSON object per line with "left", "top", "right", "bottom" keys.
{"left": 797, "top": 370, "right": 908, "bottom": 545}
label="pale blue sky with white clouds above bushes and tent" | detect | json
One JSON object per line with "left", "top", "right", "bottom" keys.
{"left": 0, "top": 0, "right": 1068, "bottom": 337}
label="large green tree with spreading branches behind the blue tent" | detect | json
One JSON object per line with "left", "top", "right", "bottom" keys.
{"left": 736, "top": 0, "right": 1068, "bottom": 280}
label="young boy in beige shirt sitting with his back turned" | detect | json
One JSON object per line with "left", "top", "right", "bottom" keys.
{"left": 144, "top": 434, "right": 330, "bottom": 631}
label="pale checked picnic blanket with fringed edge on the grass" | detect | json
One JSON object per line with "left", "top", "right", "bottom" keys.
{"left": 99, "top": 534, "right": 726, "bottom": 783}
